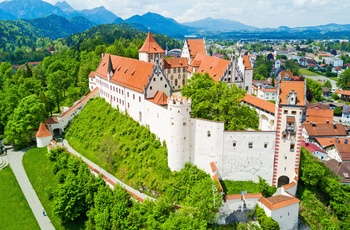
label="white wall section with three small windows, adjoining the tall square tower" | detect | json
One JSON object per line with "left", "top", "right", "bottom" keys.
{"left": 218, "top": 131, "right": 276, "bottom": 184}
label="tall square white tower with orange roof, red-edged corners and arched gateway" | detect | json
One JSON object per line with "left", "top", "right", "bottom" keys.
{"left": 273, "top": 81, "right": 306, "bottom": 190}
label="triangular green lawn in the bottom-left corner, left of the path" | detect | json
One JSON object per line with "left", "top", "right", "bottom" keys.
{"left": 0, "top": 167, "right": 40, "bottom": 230}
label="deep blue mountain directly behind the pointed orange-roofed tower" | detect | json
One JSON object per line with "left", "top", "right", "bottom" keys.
{"left": 125, "top": 12, "right": 194, "bottom": 38}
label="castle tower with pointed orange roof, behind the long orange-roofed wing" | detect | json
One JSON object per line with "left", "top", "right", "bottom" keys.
{"left": 139, "top": 32, "right": 165, "bottom": 66}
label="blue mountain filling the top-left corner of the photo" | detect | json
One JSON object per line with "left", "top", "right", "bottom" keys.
{"left": 0, "top": 0, "right": 67, "bottom": 19}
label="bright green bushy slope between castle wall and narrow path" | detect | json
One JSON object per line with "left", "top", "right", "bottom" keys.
{"left": 66, "top": 98, "right": 171, "bottom": 194}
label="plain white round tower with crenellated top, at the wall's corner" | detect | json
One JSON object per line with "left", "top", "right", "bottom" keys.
{"left": 166, "top": 97, "right": 191, "bottom": 171}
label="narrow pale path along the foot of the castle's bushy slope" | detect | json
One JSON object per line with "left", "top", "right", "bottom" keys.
{"left": 63, "top": 139, "right": 156, "bottom": 201}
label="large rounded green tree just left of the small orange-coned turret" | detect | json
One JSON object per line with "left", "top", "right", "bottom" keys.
{"left": 5, "top": 95, "right": 47, "bottom": 145}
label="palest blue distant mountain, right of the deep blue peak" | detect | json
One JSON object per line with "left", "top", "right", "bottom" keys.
{"left": 182, "top": 17, "right": 257, "bottom": 31}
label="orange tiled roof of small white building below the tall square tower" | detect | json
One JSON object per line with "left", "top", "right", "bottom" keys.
{"left": 259, "top": 195, "right": 300, "bottom": 210}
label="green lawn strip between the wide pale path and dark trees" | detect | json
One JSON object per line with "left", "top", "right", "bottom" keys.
{"left": 23, "top": 147, "right": 85, "bottom": 229}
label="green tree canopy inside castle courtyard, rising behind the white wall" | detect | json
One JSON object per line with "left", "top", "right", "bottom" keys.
{"left": 181, "top": 73, "right": 259, "bottom": 130}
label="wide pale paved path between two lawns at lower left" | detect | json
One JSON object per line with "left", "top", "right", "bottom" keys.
{"left": 7, "top": 150, "right": 55, "bottom": 230}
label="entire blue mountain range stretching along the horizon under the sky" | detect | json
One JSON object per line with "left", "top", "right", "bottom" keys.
{"left": 0, "top": 0, "right": 350, "bottom": 38}
